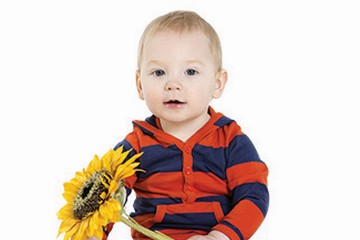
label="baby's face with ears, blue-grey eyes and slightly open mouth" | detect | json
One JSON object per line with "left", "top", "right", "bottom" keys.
{"left": 136, "top": 31, "right": 226, "bottom": 124}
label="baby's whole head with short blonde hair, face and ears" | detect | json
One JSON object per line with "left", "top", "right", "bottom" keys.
{"left": 136, "top": 11, "right": 227, "bottom": 133}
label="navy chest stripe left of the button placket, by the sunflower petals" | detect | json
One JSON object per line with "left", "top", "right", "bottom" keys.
{"left": 138, "top": 144, "right": 182, "bottom": 178}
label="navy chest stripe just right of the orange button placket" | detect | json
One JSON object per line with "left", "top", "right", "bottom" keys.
{"left": 192, "top": 144, "right": 226, "bottom": 180}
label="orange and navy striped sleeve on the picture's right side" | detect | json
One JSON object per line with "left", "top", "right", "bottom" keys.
{"left": 212, "top": 134, "right": 269, "bottom": 240}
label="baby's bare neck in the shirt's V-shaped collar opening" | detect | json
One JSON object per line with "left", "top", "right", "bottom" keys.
{"left": 160, "top": 114, "right": 210, "bottom": 142}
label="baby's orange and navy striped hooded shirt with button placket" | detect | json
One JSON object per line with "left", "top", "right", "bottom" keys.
{"left": 111, "top": 107, "right": 269, "bottom": 240}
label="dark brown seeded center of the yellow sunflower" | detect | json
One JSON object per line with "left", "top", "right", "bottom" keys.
{"left": 73, "top": 170, "right": 112, "bottom": 220}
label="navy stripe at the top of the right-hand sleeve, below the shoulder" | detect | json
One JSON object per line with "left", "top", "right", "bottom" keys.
{"left": 227, "top": 134, "right": 262, "bottom": 167}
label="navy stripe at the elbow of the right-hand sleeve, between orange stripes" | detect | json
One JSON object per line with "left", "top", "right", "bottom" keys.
{"left": 232, "top": 182, "right": 269, "bottom": 217}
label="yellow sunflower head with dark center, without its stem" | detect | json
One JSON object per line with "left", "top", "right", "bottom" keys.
{"left": 57, "top": 146, "right": 142, "bottom": 240}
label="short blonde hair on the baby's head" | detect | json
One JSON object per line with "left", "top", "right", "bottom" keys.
{"left": 137, "top": 11, "right": 222, "bottom": 70}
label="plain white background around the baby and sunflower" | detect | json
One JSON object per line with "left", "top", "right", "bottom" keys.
{"left": 0, "top": 0, "right": 360, "bottom": 240}
